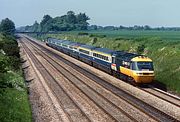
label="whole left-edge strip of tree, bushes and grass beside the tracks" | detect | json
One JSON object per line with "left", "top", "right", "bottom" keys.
{"left": 0, "top": 19, "right": 31, "bottom": 122}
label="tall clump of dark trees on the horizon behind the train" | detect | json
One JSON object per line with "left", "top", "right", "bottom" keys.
{"left": 19, "top": 11, "right": 89, "bottom": 32}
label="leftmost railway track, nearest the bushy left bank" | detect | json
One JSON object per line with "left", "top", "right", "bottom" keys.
{"left": 21, "top": 39, "right": 92, "bottom": 121}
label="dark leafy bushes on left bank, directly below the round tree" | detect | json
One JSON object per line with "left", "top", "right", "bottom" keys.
{"left": 0, "top": 35, "right": 20, "bottom": 88}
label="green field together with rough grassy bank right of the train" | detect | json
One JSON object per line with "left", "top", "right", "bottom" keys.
{"left": 32, "top": 30, "right": 180, "bottom": 93}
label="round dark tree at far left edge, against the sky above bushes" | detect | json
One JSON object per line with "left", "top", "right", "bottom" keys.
{"left": 0, "top": 18, "right": 15, "bottom": 35}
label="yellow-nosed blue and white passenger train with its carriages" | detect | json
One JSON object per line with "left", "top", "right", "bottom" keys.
{"left": 46, "top": 37, "right": 155, "bottom": 84}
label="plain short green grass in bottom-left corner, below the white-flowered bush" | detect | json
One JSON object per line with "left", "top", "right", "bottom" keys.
{"left": 0, "top": 89, "right": 31, "bottom": 122}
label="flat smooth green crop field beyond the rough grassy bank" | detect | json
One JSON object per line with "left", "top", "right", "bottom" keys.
{"left": 59, "top": 30, "right": 180, "bottom": 40}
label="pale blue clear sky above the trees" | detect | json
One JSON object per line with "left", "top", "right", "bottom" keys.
{"left": 0, "top": 0, "right": 180, "bottom": 27}
